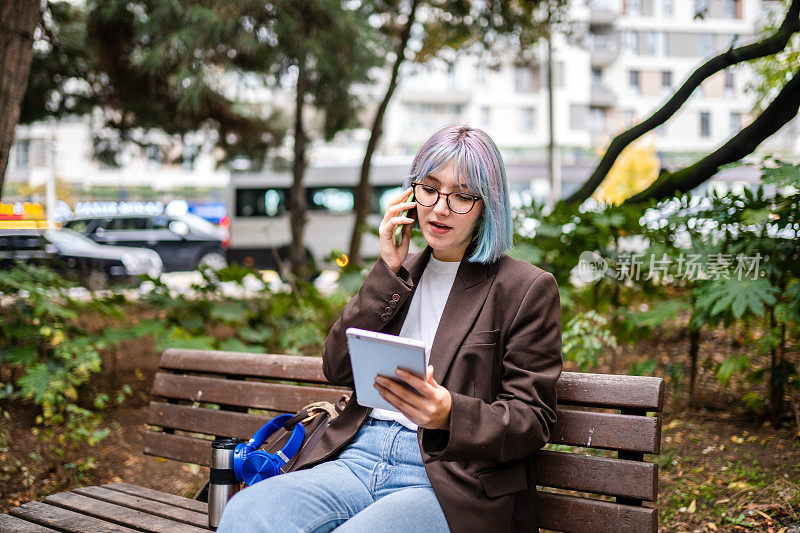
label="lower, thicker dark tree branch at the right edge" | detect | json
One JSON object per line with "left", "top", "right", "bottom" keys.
{"left": 624, "top": 62, "right": 800, "bottom": 204}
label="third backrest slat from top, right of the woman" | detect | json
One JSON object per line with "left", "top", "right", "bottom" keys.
{"left": 535, "top": 450, "right": 658, "bottom": 502}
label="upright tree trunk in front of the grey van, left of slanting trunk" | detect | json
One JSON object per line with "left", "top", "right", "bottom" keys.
{"left": 289, "top": 61, "right": 308, "bottom": 279}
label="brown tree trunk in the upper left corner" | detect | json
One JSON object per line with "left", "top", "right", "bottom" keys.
{"left": 0, "top": 0, "right": 42, "bottom": 198}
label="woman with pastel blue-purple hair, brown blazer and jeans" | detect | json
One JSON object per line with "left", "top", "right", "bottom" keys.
{"left": 219, "top": 126, "right": 562, "bottom": 533}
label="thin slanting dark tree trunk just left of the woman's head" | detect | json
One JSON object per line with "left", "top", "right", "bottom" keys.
{"left": 350, "top": 0, "right": 419, "bottom": 265}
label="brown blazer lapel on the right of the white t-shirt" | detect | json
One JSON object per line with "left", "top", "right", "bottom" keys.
{"left": 426, "top": 243, "right": 496, "bottom": 384}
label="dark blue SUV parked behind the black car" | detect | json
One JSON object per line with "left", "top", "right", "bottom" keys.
{"left": 64, "top": 213, "right": 228, "bottom": 272}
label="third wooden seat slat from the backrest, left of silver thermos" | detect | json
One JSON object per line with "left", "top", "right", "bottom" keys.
{"left": 44, "top": 492, "right": 208, "bottom": 533}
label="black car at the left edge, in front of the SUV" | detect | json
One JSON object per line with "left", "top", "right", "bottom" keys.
{"left": 0, "top": 229, "right": 163, "bottom": 290}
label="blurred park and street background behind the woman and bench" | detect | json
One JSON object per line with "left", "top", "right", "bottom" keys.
{"left": 0, "top": 0, "right": 800, "bottom": 533}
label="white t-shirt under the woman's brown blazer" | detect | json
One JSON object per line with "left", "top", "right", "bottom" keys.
{"left": 370, "top": 255, "right": 460, "bottom": 431}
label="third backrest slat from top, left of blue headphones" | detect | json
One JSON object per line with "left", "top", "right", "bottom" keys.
{"left": 147, "top": 402, "right": 268, "bottom": 439}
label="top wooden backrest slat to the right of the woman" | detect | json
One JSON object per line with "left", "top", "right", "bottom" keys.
{"left": 557, "top": 372, "right": 664, "bottom": 412}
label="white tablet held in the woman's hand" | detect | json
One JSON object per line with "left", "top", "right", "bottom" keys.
{"left": 345, "top": 328, "right": 425, "bottom": 411}
